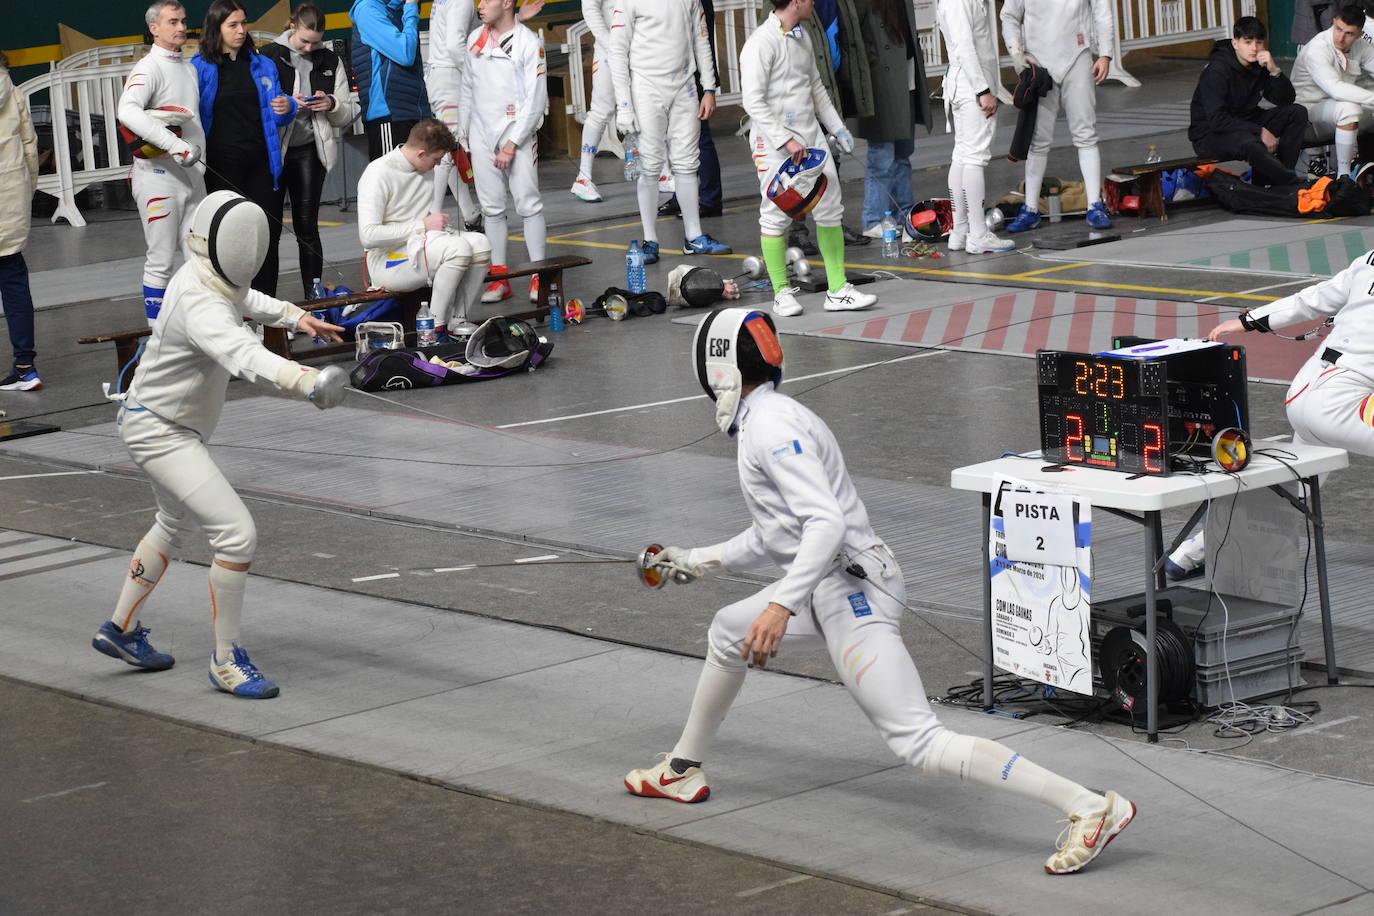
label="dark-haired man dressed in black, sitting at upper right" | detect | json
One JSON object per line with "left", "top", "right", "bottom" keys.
{"left": 1189, "top": 16, "right": 1307, "bottom": 185}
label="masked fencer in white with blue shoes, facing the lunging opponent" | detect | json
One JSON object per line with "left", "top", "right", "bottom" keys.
{"left": 91, "top": 191, "right": 348, "bottom": 699}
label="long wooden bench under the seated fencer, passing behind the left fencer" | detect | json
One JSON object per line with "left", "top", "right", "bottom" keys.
{"left": 77, "top": 254, "right": 592, "bottom": 385}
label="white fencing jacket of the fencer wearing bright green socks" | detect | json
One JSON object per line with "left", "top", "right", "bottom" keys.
{"left": 739, "top": 12, "right": 845, "bottom": 150}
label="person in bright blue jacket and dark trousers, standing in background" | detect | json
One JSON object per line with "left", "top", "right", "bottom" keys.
{"left": 349, "top": 0, "right": 430, "bottom": 159}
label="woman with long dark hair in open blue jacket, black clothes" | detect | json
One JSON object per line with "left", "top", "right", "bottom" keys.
{"left": 191, "top": 0, "right": 297, "bottom": 297}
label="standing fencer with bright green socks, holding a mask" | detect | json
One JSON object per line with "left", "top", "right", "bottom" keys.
{"left": 739, "top": 0, "right": 878, "bottom": 317}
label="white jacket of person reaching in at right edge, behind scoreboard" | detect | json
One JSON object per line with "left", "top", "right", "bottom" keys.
{"left": 1246, "top": 251, "right": 1374, "bottom": 382}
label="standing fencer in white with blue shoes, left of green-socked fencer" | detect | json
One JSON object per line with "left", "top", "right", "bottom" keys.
{"left": 610, "top": 0, "right": 730, "bottom": 264}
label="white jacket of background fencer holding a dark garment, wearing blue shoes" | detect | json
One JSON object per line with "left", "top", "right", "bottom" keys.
{"left": 1002, "top": 0, "right": 1116, "bottom": 84}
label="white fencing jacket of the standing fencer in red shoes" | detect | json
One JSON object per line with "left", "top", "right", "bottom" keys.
{"left": 458, "top": 22, "right": 548, "bottom": 152}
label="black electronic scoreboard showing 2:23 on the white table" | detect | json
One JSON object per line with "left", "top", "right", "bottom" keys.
{"left": 1036, "top": 336, "right": 1250, "bottom": 475}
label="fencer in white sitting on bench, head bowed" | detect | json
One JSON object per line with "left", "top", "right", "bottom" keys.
{"left": 357, "top": 118, "right": 492, "bottom": 336}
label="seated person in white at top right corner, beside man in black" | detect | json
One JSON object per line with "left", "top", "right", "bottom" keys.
{"left": 1293, "top": 8, "right": 1374, "bottom": 174}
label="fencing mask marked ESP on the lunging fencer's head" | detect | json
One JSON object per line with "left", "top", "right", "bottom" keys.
{"left": 692, "top": 309, "right": 782, "bottom": 435}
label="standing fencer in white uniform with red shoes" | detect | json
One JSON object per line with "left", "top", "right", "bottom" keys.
{"left": 458, "top": 0, "right": 548, "bottom": 302}
